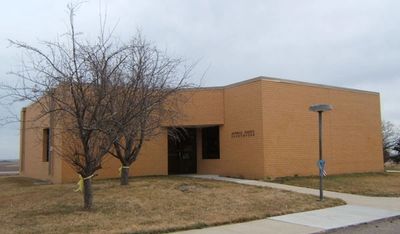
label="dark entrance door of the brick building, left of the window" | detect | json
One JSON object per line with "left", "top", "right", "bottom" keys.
{"left": 168, "top": 128, "right": 197, "bottom": 174}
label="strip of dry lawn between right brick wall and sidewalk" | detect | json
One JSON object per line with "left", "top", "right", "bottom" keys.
{"left": 273, "top": 173, "right": 400, "bottom": 197}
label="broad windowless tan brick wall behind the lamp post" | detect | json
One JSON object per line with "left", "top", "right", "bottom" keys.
{"left": 262, "top": 80, "right": 383, "bottom": 177}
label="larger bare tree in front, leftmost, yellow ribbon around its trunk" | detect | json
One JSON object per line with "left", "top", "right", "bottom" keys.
{"left": 2, "top": 5, "right": 128, "bottom": 209}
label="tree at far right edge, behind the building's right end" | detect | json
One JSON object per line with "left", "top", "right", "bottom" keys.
{"left": 382, "top": 121, "right": 400, "bottom": 162}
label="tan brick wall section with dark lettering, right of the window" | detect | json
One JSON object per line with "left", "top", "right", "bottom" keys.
{"left": 198, "top": 81, "right": 264, "bottom": 178}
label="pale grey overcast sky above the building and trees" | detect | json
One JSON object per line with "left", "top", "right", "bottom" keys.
{"left": 0, "top": 0, "right": 400, "bottom": 159}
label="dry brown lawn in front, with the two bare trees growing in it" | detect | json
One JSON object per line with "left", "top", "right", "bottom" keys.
{"left": 0, "top": 176, "right": 344, "bottom": 233}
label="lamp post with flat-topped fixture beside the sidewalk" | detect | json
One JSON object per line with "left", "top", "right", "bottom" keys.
{"left": 309, "top": 104, "right": 333, "bottom": 201}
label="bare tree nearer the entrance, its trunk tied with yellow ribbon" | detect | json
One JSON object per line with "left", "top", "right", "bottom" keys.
{"left": 110, "top": 33, "right": 191, "bottom": 185}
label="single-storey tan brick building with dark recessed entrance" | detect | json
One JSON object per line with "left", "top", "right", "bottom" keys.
{"left": 20, "top": 77, "right": 383, "bottom": 183}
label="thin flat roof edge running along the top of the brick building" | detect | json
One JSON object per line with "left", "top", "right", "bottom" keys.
{"left": 195, "top": 76, "right": 379, "bottom": 95}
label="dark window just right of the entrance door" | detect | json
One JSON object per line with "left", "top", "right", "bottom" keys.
{"left": 201, "top": 126, "right": 219, "bottom": 159}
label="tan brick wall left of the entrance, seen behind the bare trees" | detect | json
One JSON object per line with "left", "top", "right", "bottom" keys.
{"left": 21, "top": 101, "right": 168, "bottom": 183}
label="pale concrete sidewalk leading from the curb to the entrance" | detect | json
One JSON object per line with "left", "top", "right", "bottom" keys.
{"left": 173, "top": 175, "right": 400, "bottom": 234}
